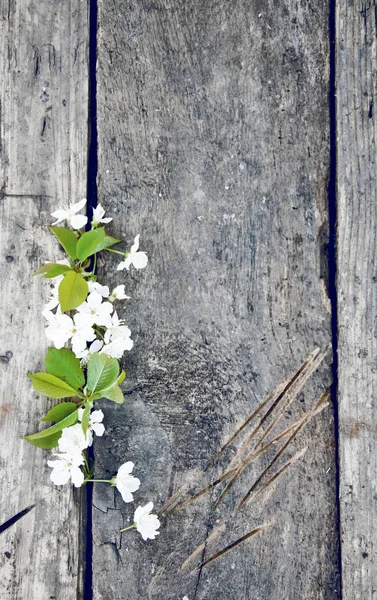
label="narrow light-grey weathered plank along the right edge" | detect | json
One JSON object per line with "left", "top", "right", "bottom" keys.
{"left": 337, "top": 0, "right": 377, "bottom": 600}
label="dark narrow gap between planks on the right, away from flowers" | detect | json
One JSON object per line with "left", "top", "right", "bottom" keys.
{"left": 327, "top": 0, "right": 343, "bottom": 599}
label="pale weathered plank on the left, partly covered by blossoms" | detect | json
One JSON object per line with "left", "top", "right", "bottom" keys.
{"left": 0, "top": 0, "right": 88, "bottom": 600}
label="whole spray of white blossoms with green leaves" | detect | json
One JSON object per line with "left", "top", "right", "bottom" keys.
{"left": 25, "top": 199, "right": 160, "bottom": 540}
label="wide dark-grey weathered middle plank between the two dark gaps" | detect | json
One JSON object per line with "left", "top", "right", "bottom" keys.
{"left": 93, "top": 0, "right": 339, "bottom": 600}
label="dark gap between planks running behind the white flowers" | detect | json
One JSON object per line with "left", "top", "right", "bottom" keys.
{"left": 82, "top": 0, "right": 98, "bottom": 600}
